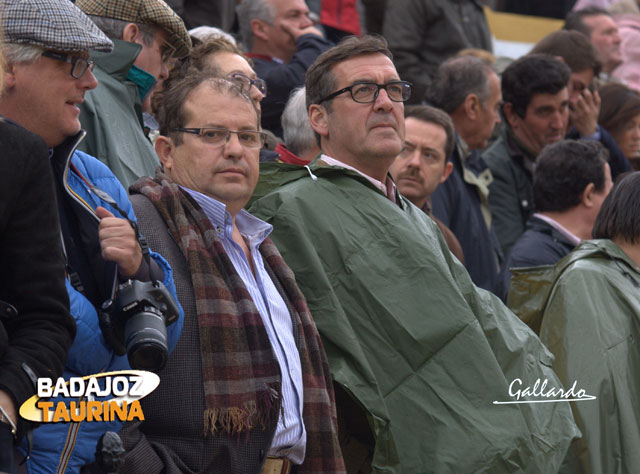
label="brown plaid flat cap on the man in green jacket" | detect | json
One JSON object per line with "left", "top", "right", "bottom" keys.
{"left": 76, "top": 0, "right": 191, "bottom": 57}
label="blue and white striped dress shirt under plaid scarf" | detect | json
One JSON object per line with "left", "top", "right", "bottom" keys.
{"left": 182, "top": 187, "right": 307, "bottom": 464}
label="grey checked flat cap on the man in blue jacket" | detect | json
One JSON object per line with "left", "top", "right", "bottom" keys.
{"left": 0, "top": 0, "right": 113, "bottom": 51}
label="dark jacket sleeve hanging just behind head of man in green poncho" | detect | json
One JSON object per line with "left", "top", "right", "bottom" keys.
{"left": 383, "top": 0, "right": 433, "bottom": 102}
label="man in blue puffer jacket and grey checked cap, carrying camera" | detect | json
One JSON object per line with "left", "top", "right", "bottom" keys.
{"left": 0, "top": 0, "right": 182, "bottom": 473}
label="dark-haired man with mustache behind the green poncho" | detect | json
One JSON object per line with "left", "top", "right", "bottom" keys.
{"left": 389, "top": 105, "right": 464, "bottom": 262}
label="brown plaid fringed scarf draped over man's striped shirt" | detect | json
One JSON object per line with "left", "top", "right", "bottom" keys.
{"left": 131, "top": 168, "right": 345, "bottom": 473}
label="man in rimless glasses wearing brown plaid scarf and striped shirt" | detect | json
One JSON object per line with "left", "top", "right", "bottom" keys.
{"left": 117, "top": 70, "right": 345, "bottom": 474}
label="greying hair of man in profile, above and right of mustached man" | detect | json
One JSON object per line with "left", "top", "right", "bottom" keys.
{"left": 427, "top": 56, "right": 495, "bottom": 115}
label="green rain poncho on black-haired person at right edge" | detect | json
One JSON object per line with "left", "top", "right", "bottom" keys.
{"left": 540, "top": 240, "right": 640, "bottom": 474}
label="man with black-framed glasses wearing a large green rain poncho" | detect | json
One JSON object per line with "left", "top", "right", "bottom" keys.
{"left": 251, "top": 37, "right": 578, "bottom": 474}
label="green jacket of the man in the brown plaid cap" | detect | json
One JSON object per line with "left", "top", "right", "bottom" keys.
{"left": 79, "top": 40, "right": 160, "bottom": 189}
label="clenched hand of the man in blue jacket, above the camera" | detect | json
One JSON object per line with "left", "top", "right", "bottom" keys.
{"left": 96, "top": 207, "right": 142, "bottom": 278}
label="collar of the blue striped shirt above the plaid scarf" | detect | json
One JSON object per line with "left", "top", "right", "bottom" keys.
{"left": 180, "top": 186, "right": 273, "bottom": 247}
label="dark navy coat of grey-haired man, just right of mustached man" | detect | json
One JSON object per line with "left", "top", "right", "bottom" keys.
{"left": 431, "top": 147, "right": 502, "bottom": 291}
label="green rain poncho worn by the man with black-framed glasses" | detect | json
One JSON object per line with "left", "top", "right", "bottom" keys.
{"left": 250, "top": 163, "right": 577, "bottom": 474}
